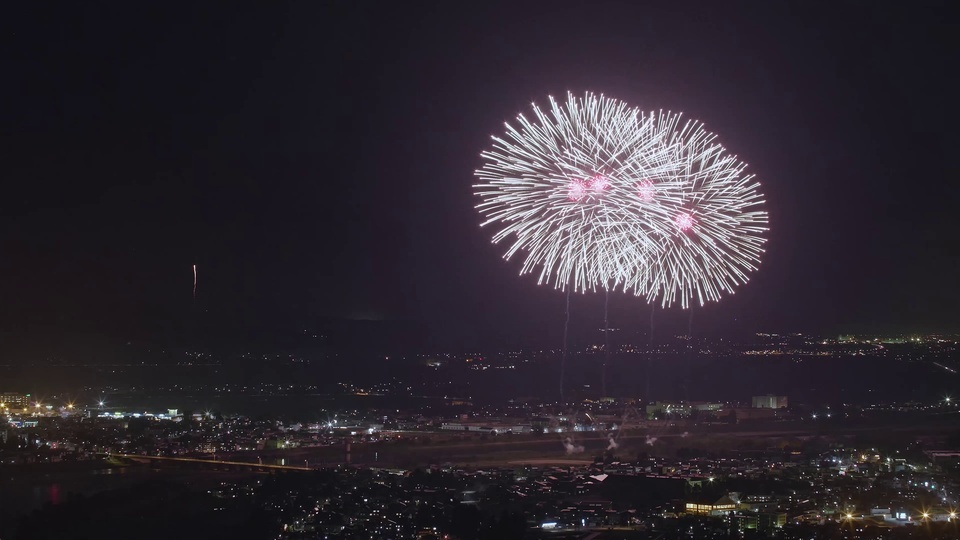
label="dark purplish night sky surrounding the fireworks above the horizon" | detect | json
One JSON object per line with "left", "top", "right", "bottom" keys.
{"left": 0, "top": 1, "right": 960, "bottom": 348}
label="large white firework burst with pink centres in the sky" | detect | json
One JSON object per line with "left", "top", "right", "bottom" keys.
{"left": 474, "top": 93, "right": 767, "bottom": 307}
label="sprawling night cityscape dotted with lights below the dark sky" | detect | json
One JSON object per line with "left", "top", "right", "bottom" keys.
{"left": 0, "top": 333, "right": 960, "bottom": 538}
